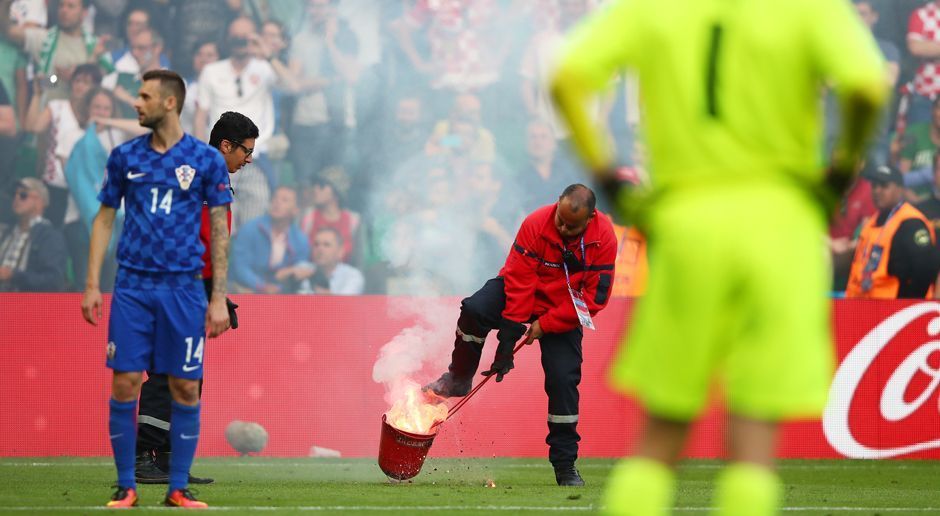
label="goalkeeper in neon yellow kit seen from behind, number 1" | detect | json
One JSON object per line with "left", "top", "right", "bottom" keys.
{"left": 551, "top": 0, "right": 887, "bottom": 516}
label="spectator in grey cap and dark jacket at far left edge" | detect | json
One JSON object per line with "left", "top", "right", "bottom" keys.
{"left": 0, "top": 177, "right": 66, "bottom": 292}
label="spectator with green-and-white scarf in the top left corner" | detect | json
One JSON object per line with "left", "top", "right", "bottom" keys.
{"left": 0, "top": 0, "right": 112, "bottom": 99}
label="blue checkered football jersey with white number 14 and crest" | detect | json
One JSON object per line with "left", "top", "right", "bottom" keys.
{"left": 98, "top": 134, "right": 232, "bottom": 272}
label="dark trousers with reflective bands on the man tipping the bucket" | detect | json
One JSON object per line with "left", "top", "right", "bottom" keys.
{"left": 448, "top": 278, "right": 584, "bottom": 467}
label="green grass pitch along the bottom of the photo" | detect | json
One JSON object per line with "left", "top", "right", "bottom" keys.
{"left": 0, "top": 457, "right": 940, "bottom": 515}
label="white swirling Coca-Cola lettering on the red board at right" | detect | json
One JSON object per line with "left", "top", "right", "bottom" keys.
{"left": 823, "top": 302, "right": 940, "bottom": 459}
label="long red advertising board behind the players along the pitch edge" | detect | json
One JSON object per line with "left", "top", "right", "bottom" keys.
{"left": 0, "top": 294, "right": 940, "bottom": 459}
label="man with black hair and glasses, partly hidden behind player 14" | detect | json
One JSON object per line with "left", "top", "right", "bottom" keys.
{"left": 134, "top": 111, "right": 258, "bottom": 484}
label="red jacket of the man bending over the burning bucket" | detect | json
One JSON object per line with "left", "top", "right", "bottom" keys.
{"left": 499, "top": 204, "right": 617, "bottom": 333}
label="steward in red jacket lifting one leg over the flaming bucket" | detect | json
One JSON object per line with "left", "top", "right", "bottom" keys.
{"left": 425, "top": 184, "right": 617, "bottom": 486}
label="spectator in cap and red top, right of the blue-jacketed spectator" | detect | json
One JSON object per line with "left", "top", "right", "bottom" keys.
{"left": 300, "top": 167, "right": 360, "bottom": 260}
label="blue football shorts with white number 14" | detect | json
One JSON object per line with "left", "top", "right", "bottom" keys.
{"left": 107, "top": 270, "right": 208, "bottom": 380}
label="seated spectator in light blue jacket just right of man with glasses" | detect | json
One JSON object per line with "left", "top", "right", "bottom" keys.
{"left": 231, "top": 186, "right": 310, "bottom": 294}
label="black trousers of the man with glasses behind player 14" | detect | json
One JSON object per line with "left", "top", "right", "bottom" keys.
{"left": 137, "top": 279, "right": 238, "bottom": 453}
